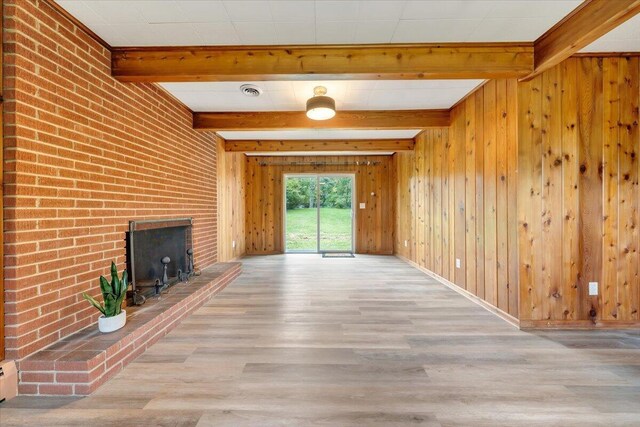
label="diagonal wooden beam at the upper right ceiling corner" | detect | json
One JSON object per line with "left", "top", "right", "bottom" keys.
{"left": 525, "top": 0, "right": 640, "bottom": 80}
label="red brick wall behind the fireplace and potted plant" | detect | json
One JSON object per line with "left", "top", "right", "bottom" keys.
{"left": 3, "top": 0, "right": 217, "bottom": 358}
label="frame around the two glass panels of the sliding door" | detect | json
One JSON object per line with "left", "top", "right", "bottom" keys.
{"left": 282, "top": 172, "right": 357, "bottom": 254}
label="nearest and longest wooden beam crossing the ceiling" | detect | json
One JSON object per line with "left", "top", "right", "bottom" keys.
{"left": 112, "top": 43, "right": 533, "bottom": 82}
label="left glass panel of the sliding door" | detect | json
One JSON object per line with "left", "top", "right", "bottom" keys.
{"left": 285, "top": 176, "right": 318, "bottom": 252}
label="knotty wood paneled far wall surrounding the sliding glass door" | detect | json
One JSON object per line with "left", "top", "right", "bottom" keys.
{"left": 246, "top": 156, "right": 395, "bottom": 255}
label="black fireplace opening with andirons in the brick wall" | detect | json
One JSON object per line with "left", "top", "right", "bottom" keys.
{"left": 126, "top": 218, "right": 194, "bottom": 304}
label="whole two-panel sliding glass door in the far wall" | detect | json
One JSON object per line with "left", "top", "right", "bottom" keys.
{"left": 284, "top": 175, "right": 354, "bottom": 253}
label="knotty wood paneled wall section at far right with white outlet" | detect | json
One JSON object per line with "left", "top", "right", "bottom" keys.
{"left": 518, "top": 57, "right": 640, "bottom": 327}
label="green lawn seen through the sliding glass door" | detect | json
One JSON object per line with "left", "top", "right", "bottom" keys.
{"left": 286, "top": 208, "right": 351, "bottom": 251}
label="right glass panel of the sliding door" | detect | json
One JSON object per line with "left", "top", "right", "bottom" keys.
{"left": 318, "top": 176, "right": 353, "bottom": 252}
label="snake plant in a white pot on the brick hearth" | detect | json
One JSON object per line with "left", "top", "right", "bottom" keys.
{"left": 82, "top": 262, "right": 129, "bottom": 333}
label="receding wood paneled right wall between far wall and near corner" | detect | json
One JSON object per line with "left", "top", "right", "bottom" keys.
{"left": 395, "top": 79, "right": 518, "bottom": 317}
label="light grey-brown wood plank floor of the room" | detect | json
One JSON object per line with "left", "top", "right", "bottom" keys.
{"left": 0, "top": 255, "right": 640, "bottom": 427}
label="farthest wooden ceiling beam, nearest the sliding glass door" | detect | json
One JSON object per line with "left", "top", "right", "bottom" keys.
{"left": 225, "top": 138, "right": 415, "bottom": 153}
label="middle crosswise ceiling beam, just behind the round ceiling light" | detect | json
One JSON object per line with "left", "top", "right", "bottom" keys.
{"left": 193, "top": 110, "right": 450, "bottom": 131}
